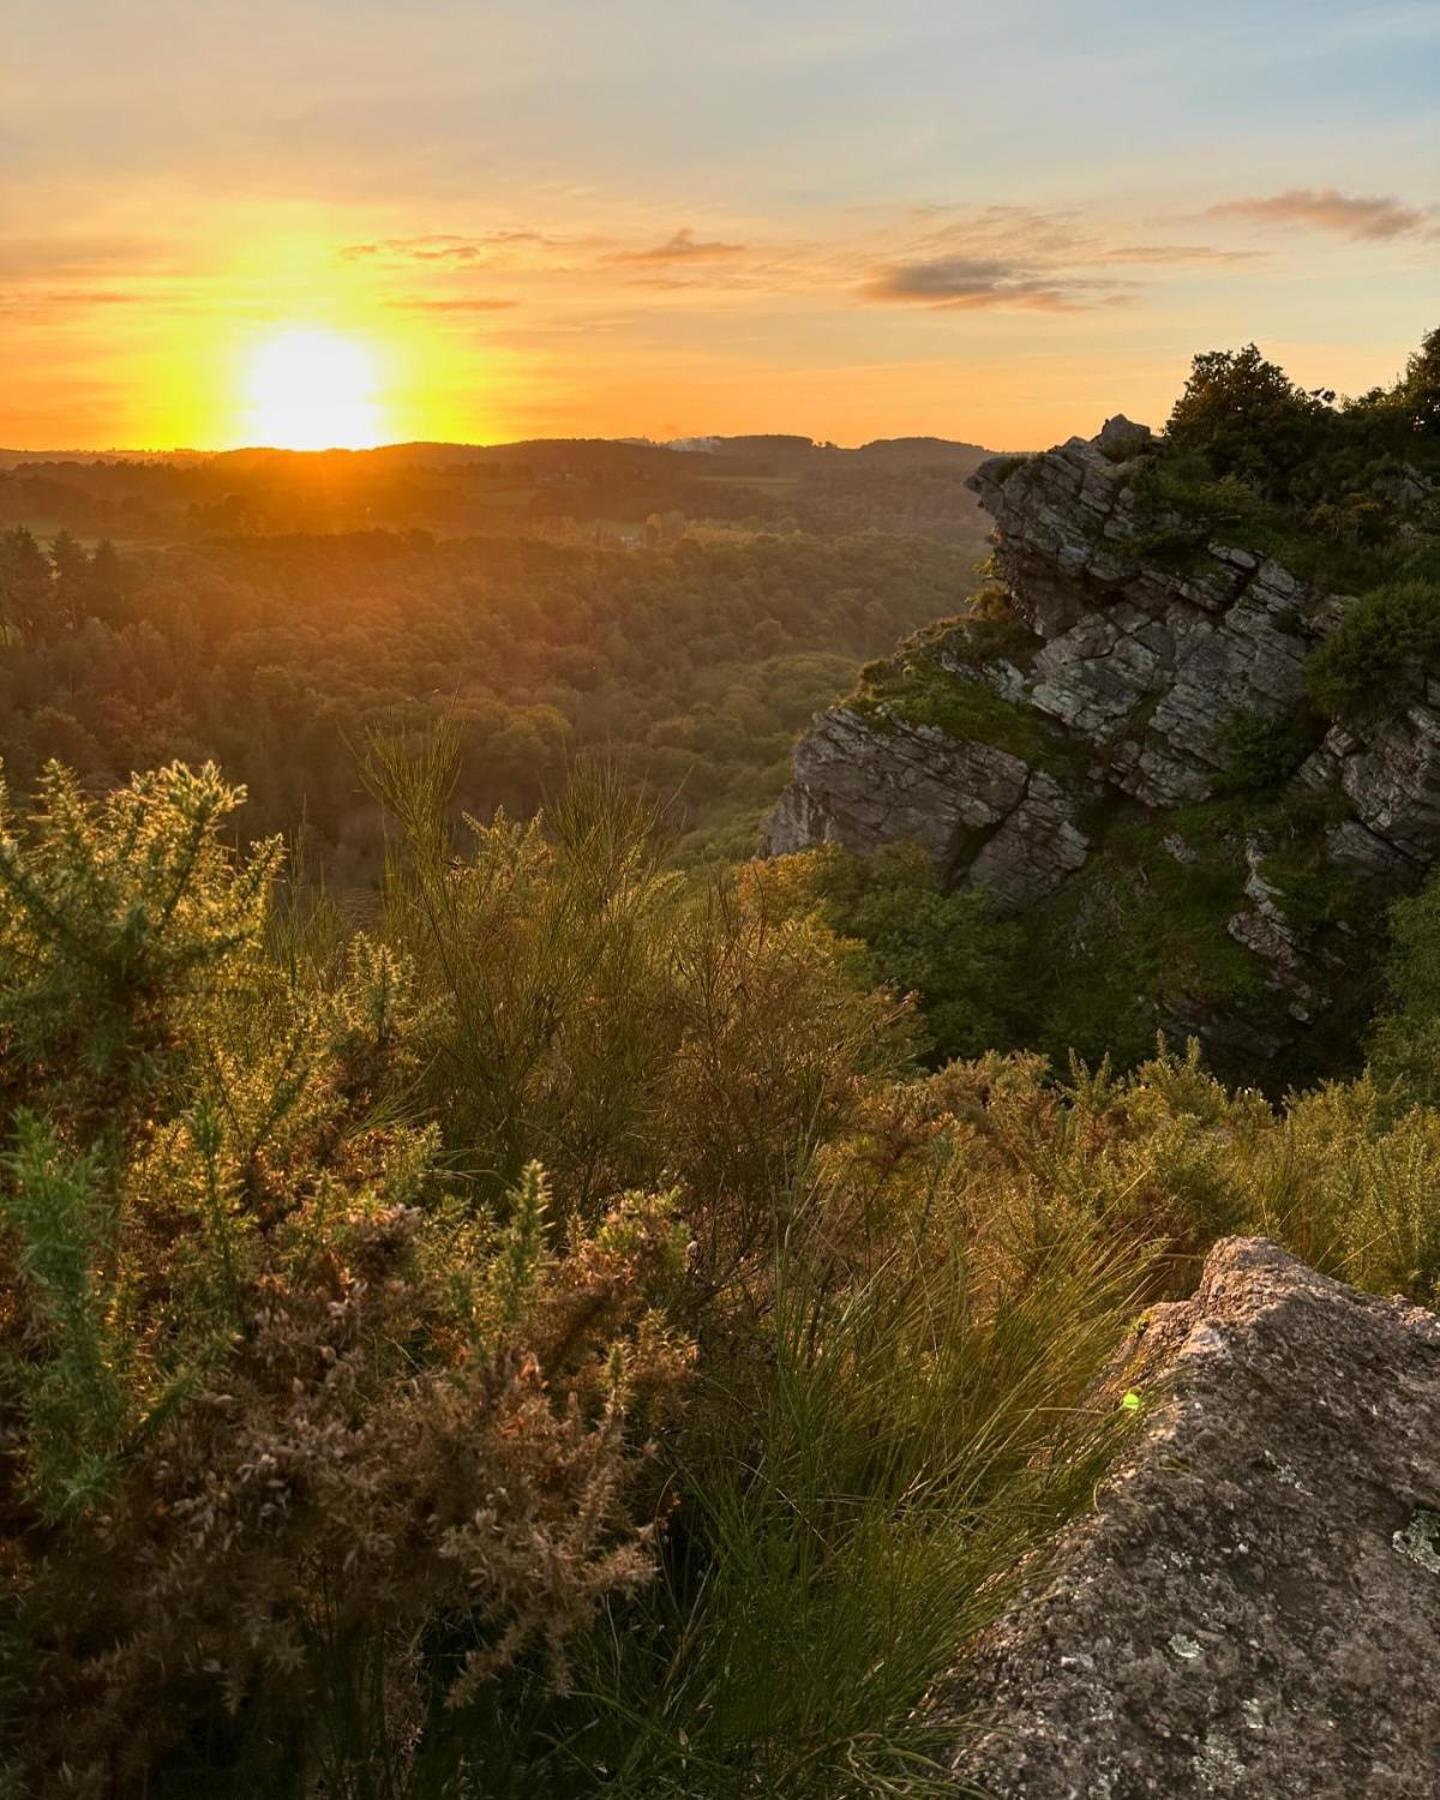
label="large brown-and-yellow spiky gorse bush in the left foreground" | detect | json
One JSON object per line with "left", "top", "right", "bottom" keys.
{"left": 0, "top": 769, "right": 689, "bottom": 1793}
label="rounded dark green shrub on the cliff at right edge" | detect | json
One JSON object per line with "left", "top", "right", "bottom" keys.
{"left": 1305, "top": 581, "right": 1440, "bottom": 727}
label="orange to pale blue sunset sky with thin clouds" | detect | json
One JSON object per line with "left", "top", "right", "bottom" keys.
{"left": 0, "top": 0, "right": 1440, "bottom": 448}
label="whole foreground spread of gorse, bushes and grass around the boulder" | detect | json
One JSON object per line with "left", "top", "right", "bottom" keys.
{"left": 0, "top": 743, "right": 1440, "bottom": 1800}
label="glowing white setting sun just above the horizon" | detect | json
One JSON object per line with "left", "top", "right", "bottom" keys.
{"left": 245, "top": 331, "right": 385, "bottom": 450}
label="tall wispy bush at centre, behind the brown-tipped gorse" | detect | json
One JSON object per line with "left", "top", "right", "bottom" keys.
{"left": 373, "top": 738, "right": 909, "bottom": 1291}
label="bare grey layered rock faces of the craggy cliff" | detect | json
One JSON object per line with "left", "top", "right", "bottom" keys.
{"left": 765, "top": 419, "right": 1440, "bottom": 1058}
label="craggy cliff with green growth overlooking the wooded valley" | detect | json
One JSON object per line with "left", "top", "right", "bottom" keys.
{"left": 765, "top": 419, "right": 1440, "bottom": 1069}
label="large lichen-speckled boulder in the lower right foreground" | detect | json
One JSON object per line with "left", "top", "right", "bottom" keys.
{"left": 941, "top": 1238, "right": 1440, "bottom": 1800}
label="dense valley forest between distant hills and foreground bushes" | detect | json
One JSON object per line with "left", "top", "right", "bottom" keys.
{"left": 0, "top": 525, "right": 981, "bottom": 886}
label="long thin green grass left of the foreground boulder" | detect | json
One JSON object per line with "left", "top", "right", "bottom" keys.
{"left": 579, "top": 1188, "right": 1141, "bottom": 1800}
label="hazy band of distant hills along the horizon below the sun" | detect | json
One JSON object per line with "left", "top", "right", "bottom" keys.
{"left": 0, "top": 434, "right": 988, "bottom": 544}
